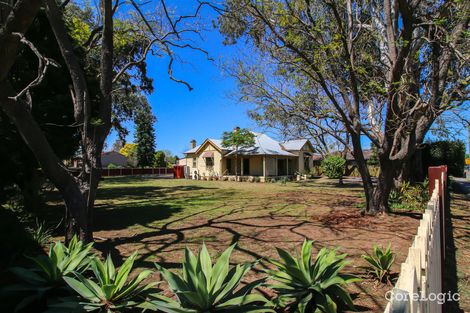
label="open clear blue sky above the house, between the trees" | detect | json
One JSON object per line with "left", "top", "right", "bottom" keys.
{"left": 107, "top": 2, "right": 256, "bottom": 156}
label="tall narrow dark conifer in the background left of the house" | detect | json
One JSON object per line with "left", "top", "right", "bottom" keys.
{"left": 134, "top": 97, "right": 155, "bottom": 167}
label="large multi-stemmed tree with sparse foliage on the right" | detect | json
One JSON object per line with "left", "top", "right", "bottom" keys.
{"left": 219, "top": 0, "right": 470, "bottom": 214}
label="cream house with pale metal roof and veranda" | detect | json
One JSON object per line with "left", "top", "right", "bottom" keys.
{"left": 184, "top": 133, "right": 314, "bottom": 181}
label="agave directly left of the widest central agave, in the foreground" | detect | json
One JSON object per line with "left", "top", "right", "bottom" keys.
{"left": 60, "top": 253, "right": 156, "bottom": 312}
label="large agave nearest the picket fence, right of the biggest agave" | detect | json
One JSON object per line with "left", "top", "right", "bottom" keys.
{"left": 268, "top": 240, "right": 359, "bottom": 313}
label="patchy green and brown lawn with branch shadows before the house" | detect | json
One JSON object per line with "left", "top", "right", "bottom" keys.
{"left": 48, "top": 177, "right": 419, "bottom": 312}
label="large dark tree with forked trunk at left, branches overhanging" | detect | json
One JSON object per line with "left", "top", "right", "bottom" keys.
{"left": 0, "top": 0, "right": 209, "bottom": 241}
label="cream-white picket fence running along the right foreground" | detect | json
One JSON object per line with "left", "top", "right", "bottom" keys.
{"left": 385, "top": 177, "right": 445, "bottom": 313}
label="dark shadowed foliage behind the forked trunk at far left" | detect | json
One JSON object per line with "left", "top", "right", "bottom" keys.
{"left": 0, "top": 12, "right": 79, "bottom": 207}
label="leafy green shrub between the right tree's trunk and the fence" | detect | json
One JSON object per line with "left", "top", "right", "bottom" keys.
{"left": 388, "top": 180, "right": 429, "bottom": 212}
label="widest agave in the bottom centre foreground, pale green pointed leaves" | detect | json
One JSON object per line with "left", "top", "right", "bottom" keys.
{"left": 151, "top": 244, "right": 274, "bottom": 313}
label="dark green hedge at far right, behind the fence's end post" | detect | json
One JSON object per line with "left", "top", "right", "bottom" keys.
{"left": 422, "top": 140, "right": 465, "bottom": 177}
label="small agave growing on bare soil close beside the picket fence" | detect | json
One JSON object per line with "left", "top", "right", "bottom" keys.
{"left": 362, "top": 244, "right": 395, "bottom": 283}
